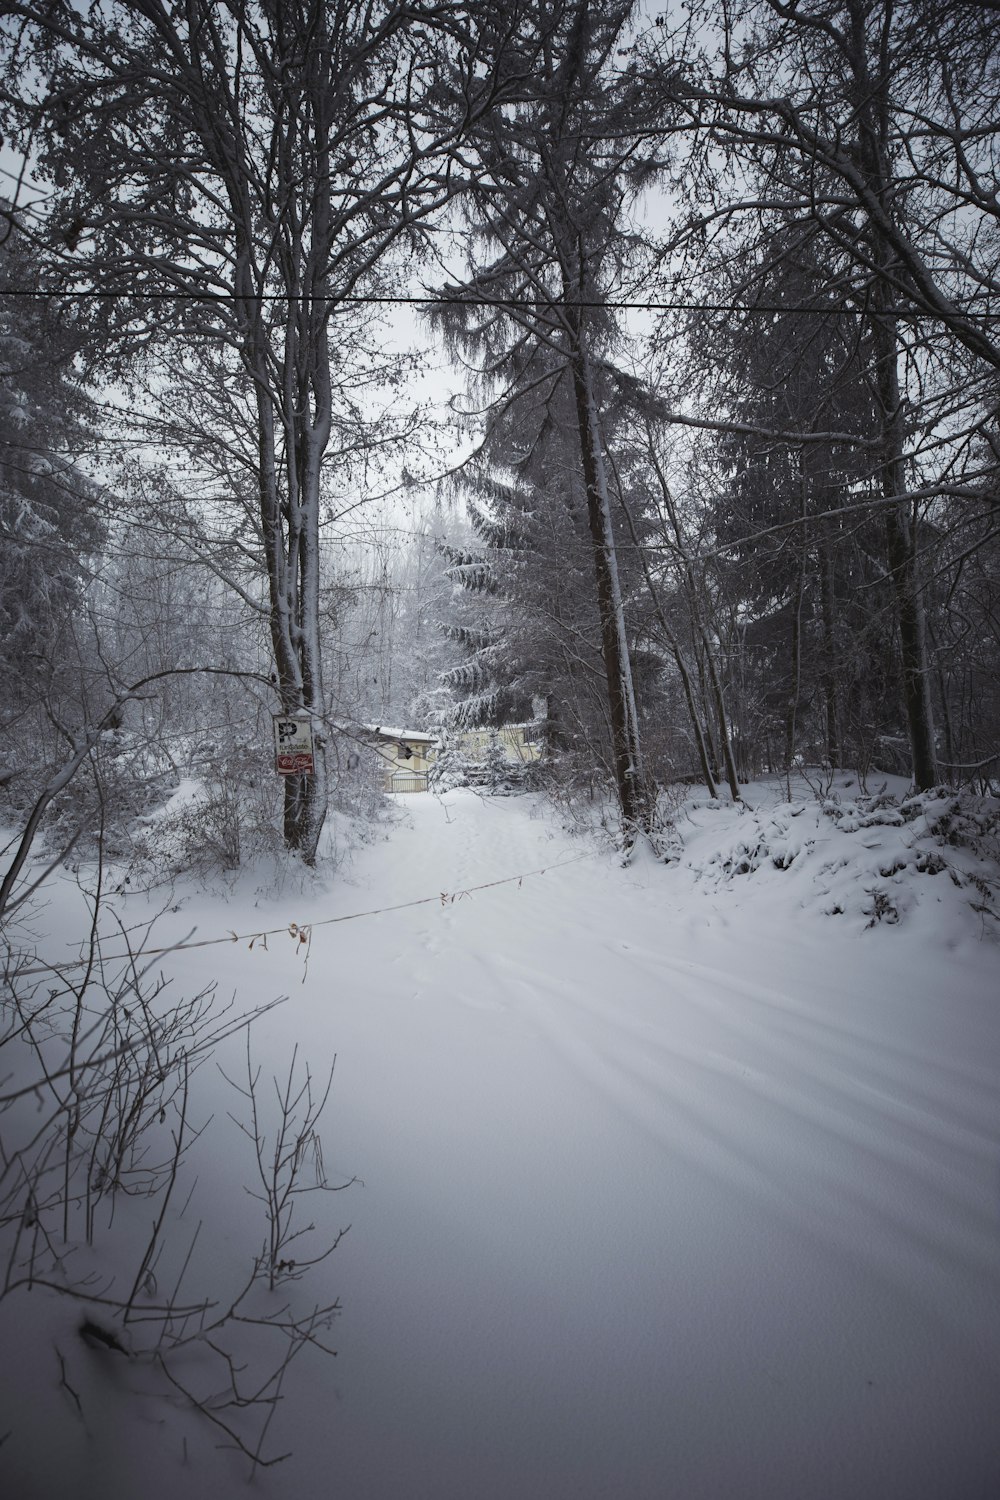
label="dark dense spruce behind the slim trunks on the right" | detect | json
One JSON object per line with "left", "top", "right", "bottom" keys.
{"left": 671, "top": 216, "right": 906, "bottom": 771}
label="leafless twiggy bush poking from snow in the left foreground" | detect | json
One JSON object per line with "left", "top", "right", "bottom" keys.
{"left": 0, "top": 891, "right": 340, "bottom": 1475}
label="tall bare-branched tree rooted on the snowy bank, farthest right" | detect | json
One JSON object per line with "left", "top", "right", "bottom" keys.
{"left": 649, "top": 0, "right": 1000, "bottom": 788}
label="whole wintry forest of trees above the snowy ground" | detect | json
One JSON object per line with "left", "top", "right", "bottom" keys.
{"left": 0, "top": 0, "right": 1000, "bottom": 876}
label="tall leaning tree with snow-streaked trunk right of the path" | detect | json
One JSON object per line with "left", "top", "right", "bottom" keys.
{"left": 425, "top": 0, "right": 659, "bottom": 837}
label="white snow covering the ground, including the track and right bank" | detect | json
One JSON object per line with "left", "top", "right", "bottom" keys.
{"left": 0, "top": 786, "right": 1000, "bottom": 1500}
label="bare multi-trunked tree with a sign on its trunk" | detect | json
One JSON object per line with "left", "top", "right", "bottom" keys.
{"left": 3, "top": 0, "right": 519, "bottom": 861}
